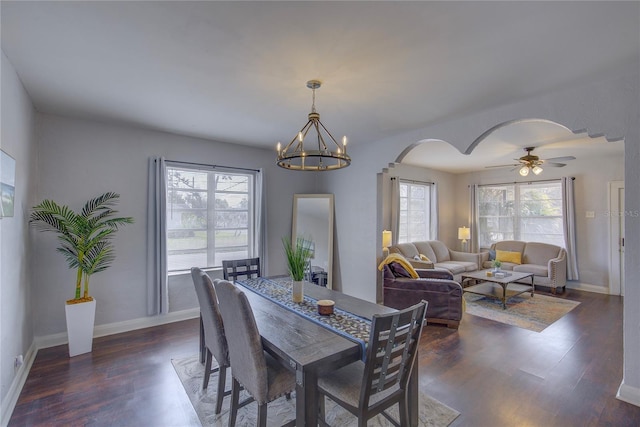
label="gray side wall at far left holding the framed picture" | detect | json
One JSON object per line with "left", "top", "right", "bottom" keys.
{"left": 0, "top": 52, "right": 36, "bottom": 413}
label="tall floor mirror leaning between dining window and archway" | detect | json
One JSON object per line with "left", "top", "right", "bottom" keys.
{"left": 291, "top": 194, "right": 333, "bottom": 289}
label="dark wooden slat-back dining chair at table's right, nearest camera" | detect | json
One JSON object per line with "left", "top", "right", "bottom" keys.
{"left": 318, "top": 300, "right": 427, "bottom": 427}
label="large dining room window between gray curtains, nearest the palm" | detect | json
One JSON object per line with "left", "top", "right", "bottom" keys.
{"left": 167, "top": 163, "right": 258, "bottom": 271}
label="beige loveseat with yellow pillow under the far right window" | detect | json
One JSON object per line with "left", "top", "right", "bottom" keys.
{"left": 480, "top": 240, "right": 567, "bottom": 294}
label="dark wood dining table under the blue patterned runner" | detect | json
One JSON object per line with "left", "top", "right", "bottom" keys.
{"left": 235, "top": 281, "right": 418, "bottom": 427}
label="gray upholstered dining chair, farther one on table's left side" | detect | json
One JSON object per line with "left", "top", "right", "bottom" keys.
{"left": 191, "top": 267, "right": 231, "bottom": 414}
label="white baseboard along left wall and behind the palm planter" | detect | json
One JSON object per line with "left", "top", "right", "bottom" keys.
{"left": 0, "top": 308, "right": 200, "bottom": 427}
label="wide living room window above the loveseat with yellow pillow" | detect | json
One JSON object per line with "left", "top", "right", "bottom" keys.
{"left": 477, "top": 181, "right": 565, "bottom": 247}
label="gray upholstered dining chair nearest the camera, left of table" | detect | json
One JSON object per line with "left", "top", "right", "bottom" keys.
{"left": 215, "top": 280, "right": 296, "bottom": 427}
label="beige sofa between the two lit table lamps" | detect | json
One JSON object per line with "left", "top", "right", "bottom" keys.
{"left": 389, "top": 240, "right": 481, "bottom": 282}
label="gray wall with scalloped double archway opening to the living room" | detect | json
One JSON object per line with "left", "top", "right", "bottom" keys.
{"left": 323, "top": 58, "right": 640, "bottom": 403}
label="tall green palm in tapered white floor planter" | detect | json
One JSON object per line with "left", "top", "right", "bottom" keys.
{"left": 29, "top": 192, "right": 133, "bottom": 357}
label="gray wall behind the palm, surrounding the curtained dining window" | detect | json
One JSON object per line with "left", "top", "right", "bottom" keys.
{"left": 33, "top": 115, "right": 315, "bottom": 336}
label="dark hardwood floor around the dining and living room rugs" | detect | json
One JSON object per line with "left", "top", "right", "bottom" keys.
{"left": 9, "top": 290, "right": 640, "bottom": 427}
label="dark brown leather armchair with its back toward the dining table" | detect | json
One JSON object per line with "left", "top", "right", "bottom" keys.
{"left": 383, "top": 264, "right": 462, "bottom": 329}
